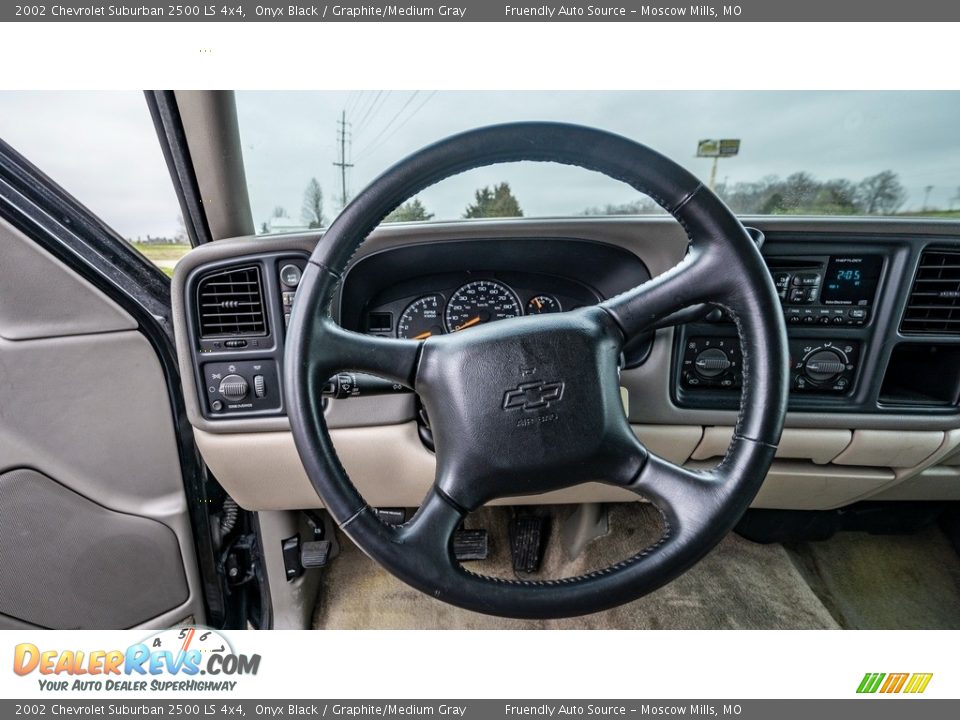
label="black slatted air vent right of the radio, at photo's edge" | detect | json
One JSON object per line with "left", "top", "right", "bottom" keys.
{"left": 900, "top": 250, "right": 960, "bottom": 335}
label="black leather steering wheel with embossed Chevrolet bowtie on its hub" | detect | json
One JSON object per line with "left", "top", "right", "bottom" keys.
{"left": 285, "top": 122, "right": 788, "bottom": 618}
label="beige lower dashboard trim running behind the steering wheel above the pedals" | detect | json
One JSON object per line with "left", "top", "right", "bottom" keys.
{"left": 196, "top": 422, "right": 924, "bottom": 510}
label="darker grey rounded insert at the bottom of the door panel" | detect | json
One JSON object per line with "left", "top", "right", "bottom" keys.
{"left": 0, "top": 468, "right": 188, "bottom": 628}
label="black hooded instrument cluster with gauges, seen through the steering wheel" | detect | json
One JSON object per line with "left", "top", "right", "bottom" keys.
{"left": 338, "top": 238, "right": 650, "bottom": 365}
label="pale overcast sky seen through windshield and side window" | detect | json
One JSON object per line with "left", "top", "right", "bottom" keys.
{"left": 0, "top": 90, "right": 960, "bottom": 238}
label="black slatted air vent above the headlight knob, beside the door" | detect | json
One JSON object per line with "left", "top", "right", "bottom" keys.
{"left": 197, "top": 265, "right": 267, "bottom": 338}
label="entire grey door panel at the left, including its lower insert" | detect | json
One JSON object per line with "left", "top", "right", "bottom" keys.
{"left": 0, "top": 221, "right": 204, "bottom": 628}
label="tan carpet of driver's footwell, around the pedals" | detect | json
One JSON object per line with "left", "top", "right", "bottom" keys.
{"left": 314, "top": 503, "right": 839, "bottom": 629}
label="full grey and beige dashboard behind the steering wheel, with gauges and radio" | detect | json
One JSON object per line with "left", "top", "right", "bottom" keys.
{"left": 174, "top": 218, "right": 960, "bottom": 508}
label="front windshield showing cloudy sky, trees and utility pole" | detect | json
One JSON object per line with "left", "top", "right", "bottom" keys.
{"left": 237, "top": 90, "right": 960, "bottom": 234}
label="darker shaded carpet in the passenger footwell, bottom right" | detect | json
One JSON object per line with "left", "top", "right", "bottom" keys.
{"left": 789, "top": 527, "right": 960, "bottom": 630}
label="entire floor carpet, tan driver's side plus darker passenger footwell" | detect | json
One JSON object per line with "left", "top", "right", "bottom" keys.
{"left": 314, "top": 503, "right": 960, "bottom": 629}
